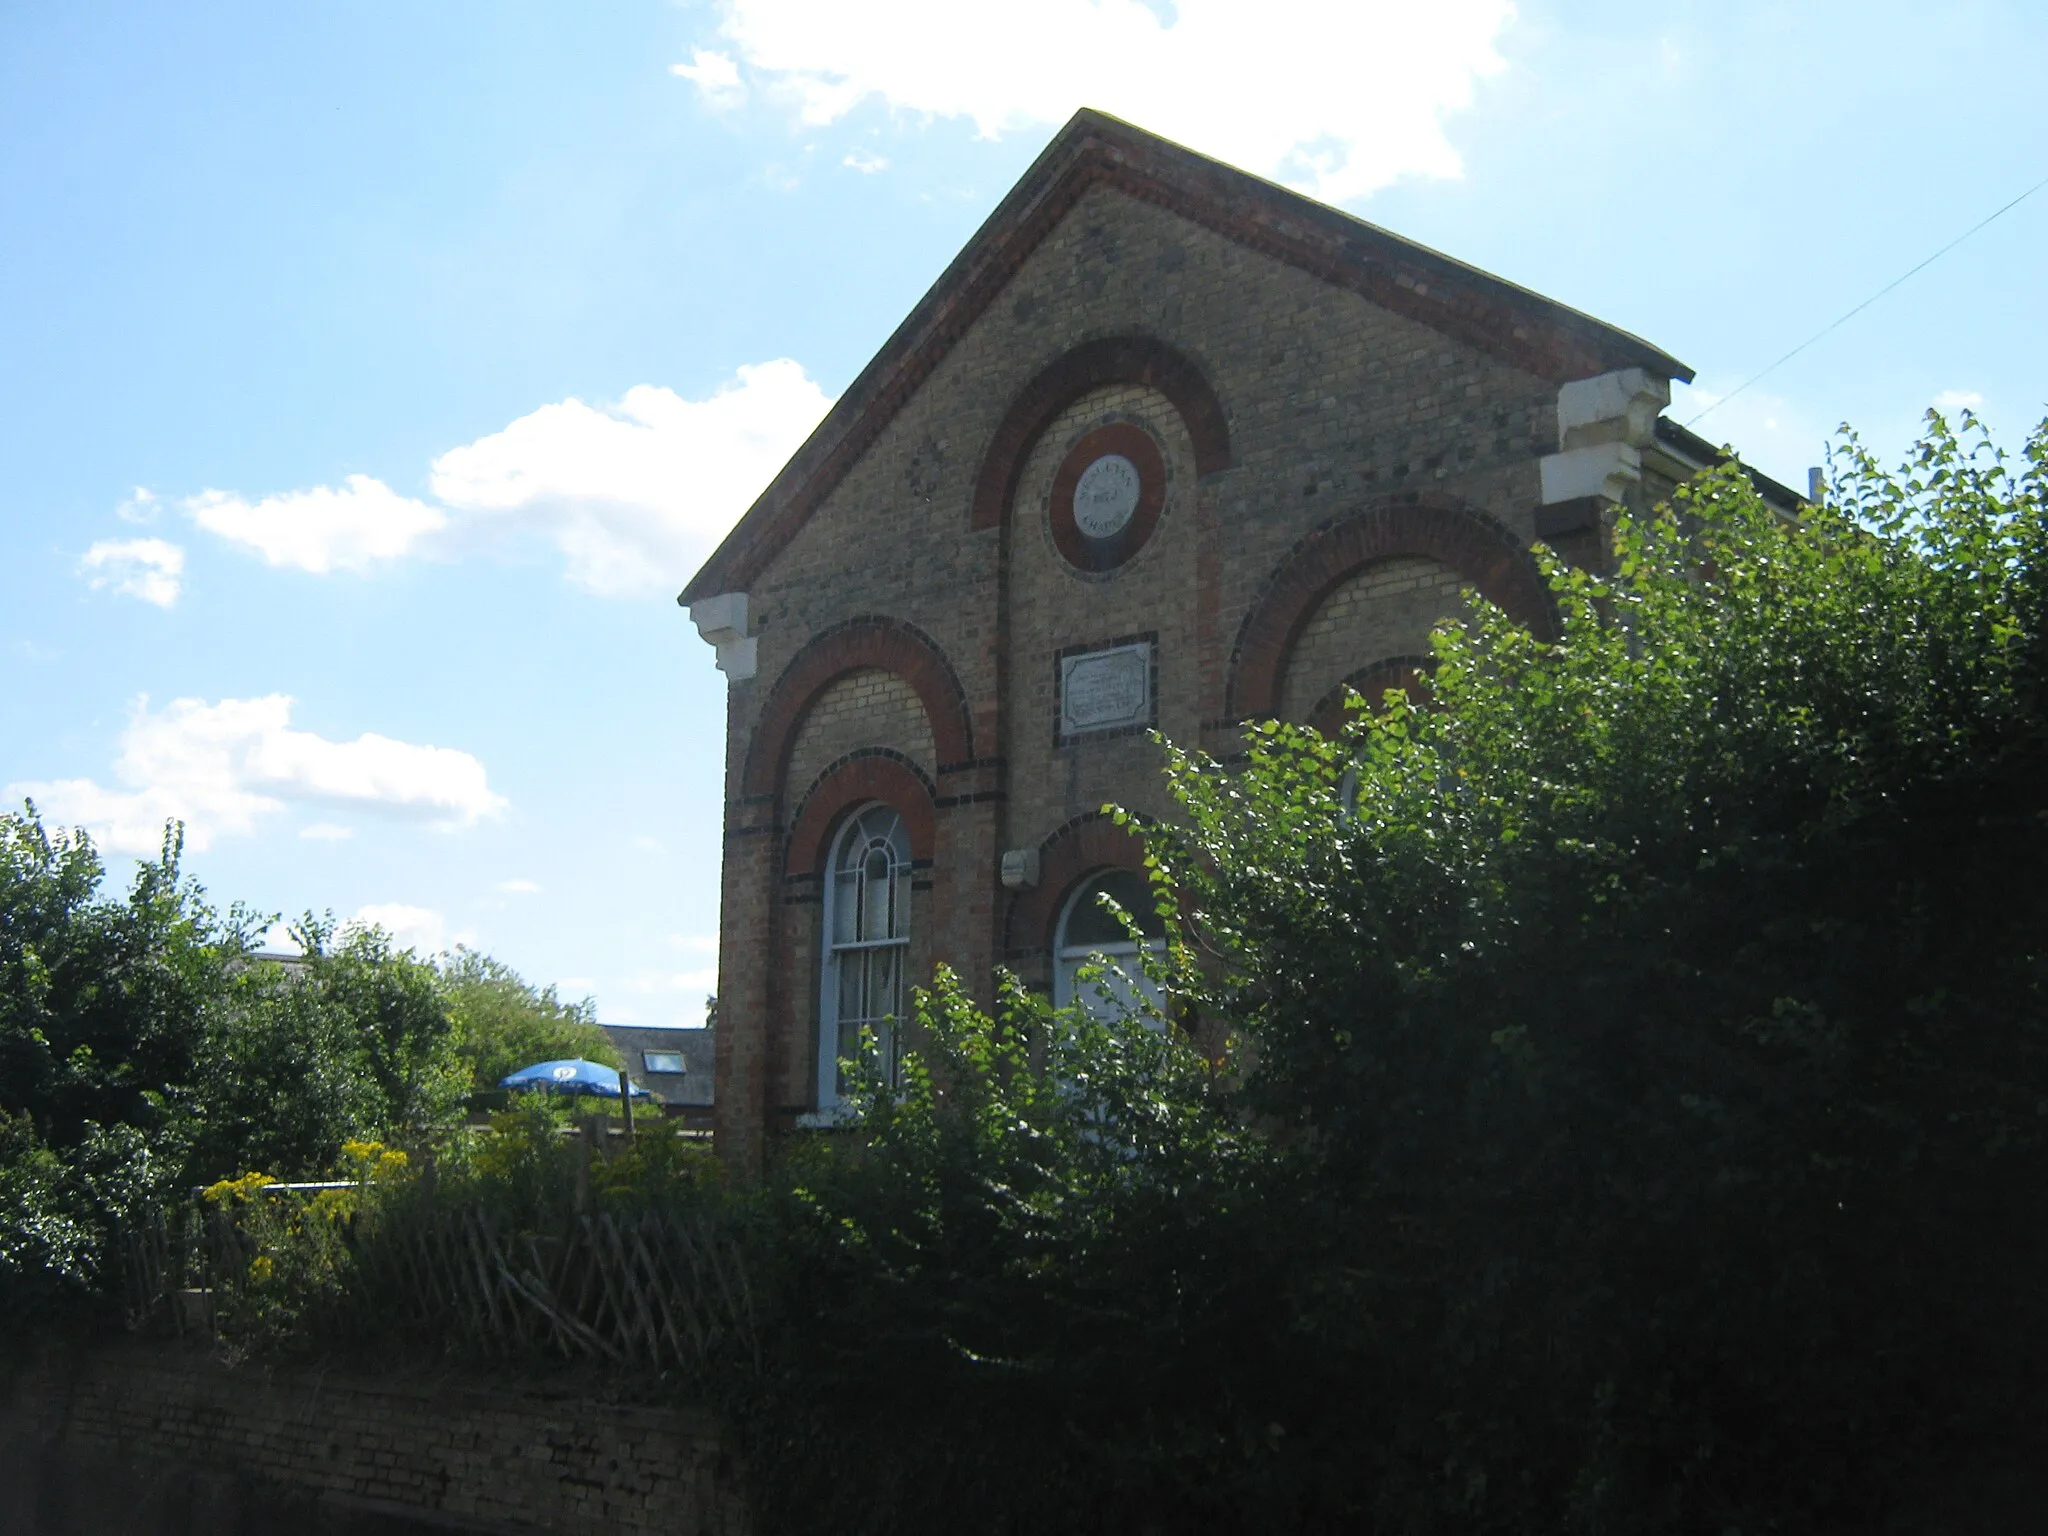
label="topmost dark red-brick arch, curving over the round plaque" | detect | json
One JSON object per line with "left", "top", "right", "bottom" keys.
{"left": 967, "top": 336, "right": 1231, "bottom": 530}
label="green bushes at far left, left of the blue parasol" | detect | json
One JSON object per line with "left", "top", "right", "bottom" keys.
{"left": 0, "top": 805, "right": 465, "bottom": 1294}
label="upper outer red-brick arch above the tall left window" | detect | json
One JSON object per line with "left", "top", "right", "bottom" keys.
{"left": 741, "top": 616, "right": 975, "bottom": 797}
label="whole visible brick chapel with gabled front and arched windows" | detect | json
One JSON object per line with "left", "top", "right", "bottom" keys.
{"left": 680, "top": 111, "right": 1790, "bottom": 1163}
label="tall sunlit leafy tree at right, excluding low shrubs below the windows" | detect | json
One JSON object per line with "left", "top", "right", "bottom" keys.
{"left": 1153, "top": 418, "right": 2048, "bottom": 1532}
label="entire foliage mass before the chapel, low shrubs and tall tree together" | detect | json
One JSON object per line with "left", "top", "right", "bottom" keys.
{"left": 741, "top": 418, "right": 2048, "bottom": 1534}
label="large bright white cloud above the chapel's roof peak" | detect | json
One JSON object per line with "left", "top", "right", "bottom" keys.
{"left": 674, "top": 0, "right": 1516, "bottom": 201}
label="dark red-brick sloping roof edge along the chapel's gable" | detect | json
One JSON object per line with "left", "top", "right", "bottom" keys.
{"left": 678, "top": 106, "right": 1692, "bottom": 604}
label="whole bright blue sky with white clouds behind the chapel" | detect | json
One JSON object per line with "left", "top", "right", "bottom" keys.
{"left": 0, "top": 0, "right": 2048, "bottom": 1024}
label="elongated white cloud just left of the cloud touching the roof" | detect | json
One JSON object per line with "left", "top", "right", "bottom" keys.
{"left": 184, "top": 475, "right": 446, "bottom": 575}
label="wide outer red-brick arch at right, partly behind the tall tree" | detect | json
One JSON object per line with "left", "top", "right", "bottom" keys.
{"left": 1225, "top": 492, "right": 1556, "bottom": 721}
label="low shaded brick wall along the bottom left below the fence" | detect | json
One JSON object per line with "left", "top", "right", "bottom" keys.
{"left": 0, "top": 1346, "right": 745, "bottom": 1536}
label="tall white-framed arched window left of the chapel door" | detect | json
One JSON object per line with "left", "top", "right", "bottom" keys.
{"left": 817, "top": 805, "right": 909, "bottom": 1110}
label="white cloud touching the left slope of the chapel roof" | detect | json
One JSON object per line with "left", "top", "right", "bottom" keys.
{"left": 432, "top": 358, "right": 831, "bottom": 598}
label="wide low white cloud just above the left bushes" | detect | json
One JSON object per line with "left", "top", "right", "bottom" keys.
{"left": 6, "top": 694, "right": 506, "bottom": 854}
